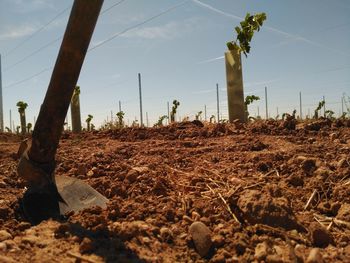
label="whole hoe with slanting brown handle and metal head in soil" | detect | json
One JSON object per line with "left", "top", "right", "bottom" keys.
{"left": 17, "top": 0, "right": 108, "bottom": 224}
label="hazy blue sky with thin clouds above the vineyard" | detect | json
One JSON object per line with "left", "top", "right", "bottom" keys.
{"left": 0, "top": 0, "right": 350, "bottom": 130}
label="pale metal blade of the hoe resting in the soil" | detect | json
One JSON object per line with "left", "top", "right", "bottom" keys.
{"left": 55, "top": 175, "right": 108, "bottom": 215}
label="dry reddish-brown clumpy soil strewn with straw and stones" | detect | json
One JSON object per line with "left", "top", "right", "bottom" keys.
{"left": 0, "top": 119, "right": 350, "bottom": 262}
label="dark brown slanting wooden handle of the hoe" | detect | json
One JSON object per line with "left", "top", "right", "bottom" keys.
{"left": 29, "top": 0, "right": 103, "bottom": 169}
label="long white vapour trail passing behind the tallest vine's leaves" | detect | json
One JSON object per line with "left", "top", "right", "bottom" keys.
{"left": 192, "top": 0, "right": 350, "bottom": 57}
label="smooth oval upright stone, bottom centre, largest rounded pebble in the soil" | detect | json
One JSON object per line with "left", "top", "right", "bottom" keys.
{"left": 189, "top": 221, "right": 212, "bottom": 257}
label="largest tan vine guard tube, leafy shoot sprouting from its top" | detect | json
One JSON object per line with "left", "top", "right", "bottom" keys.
{"left": 225, "top": 51, "right": 247, "bottom": 122}
